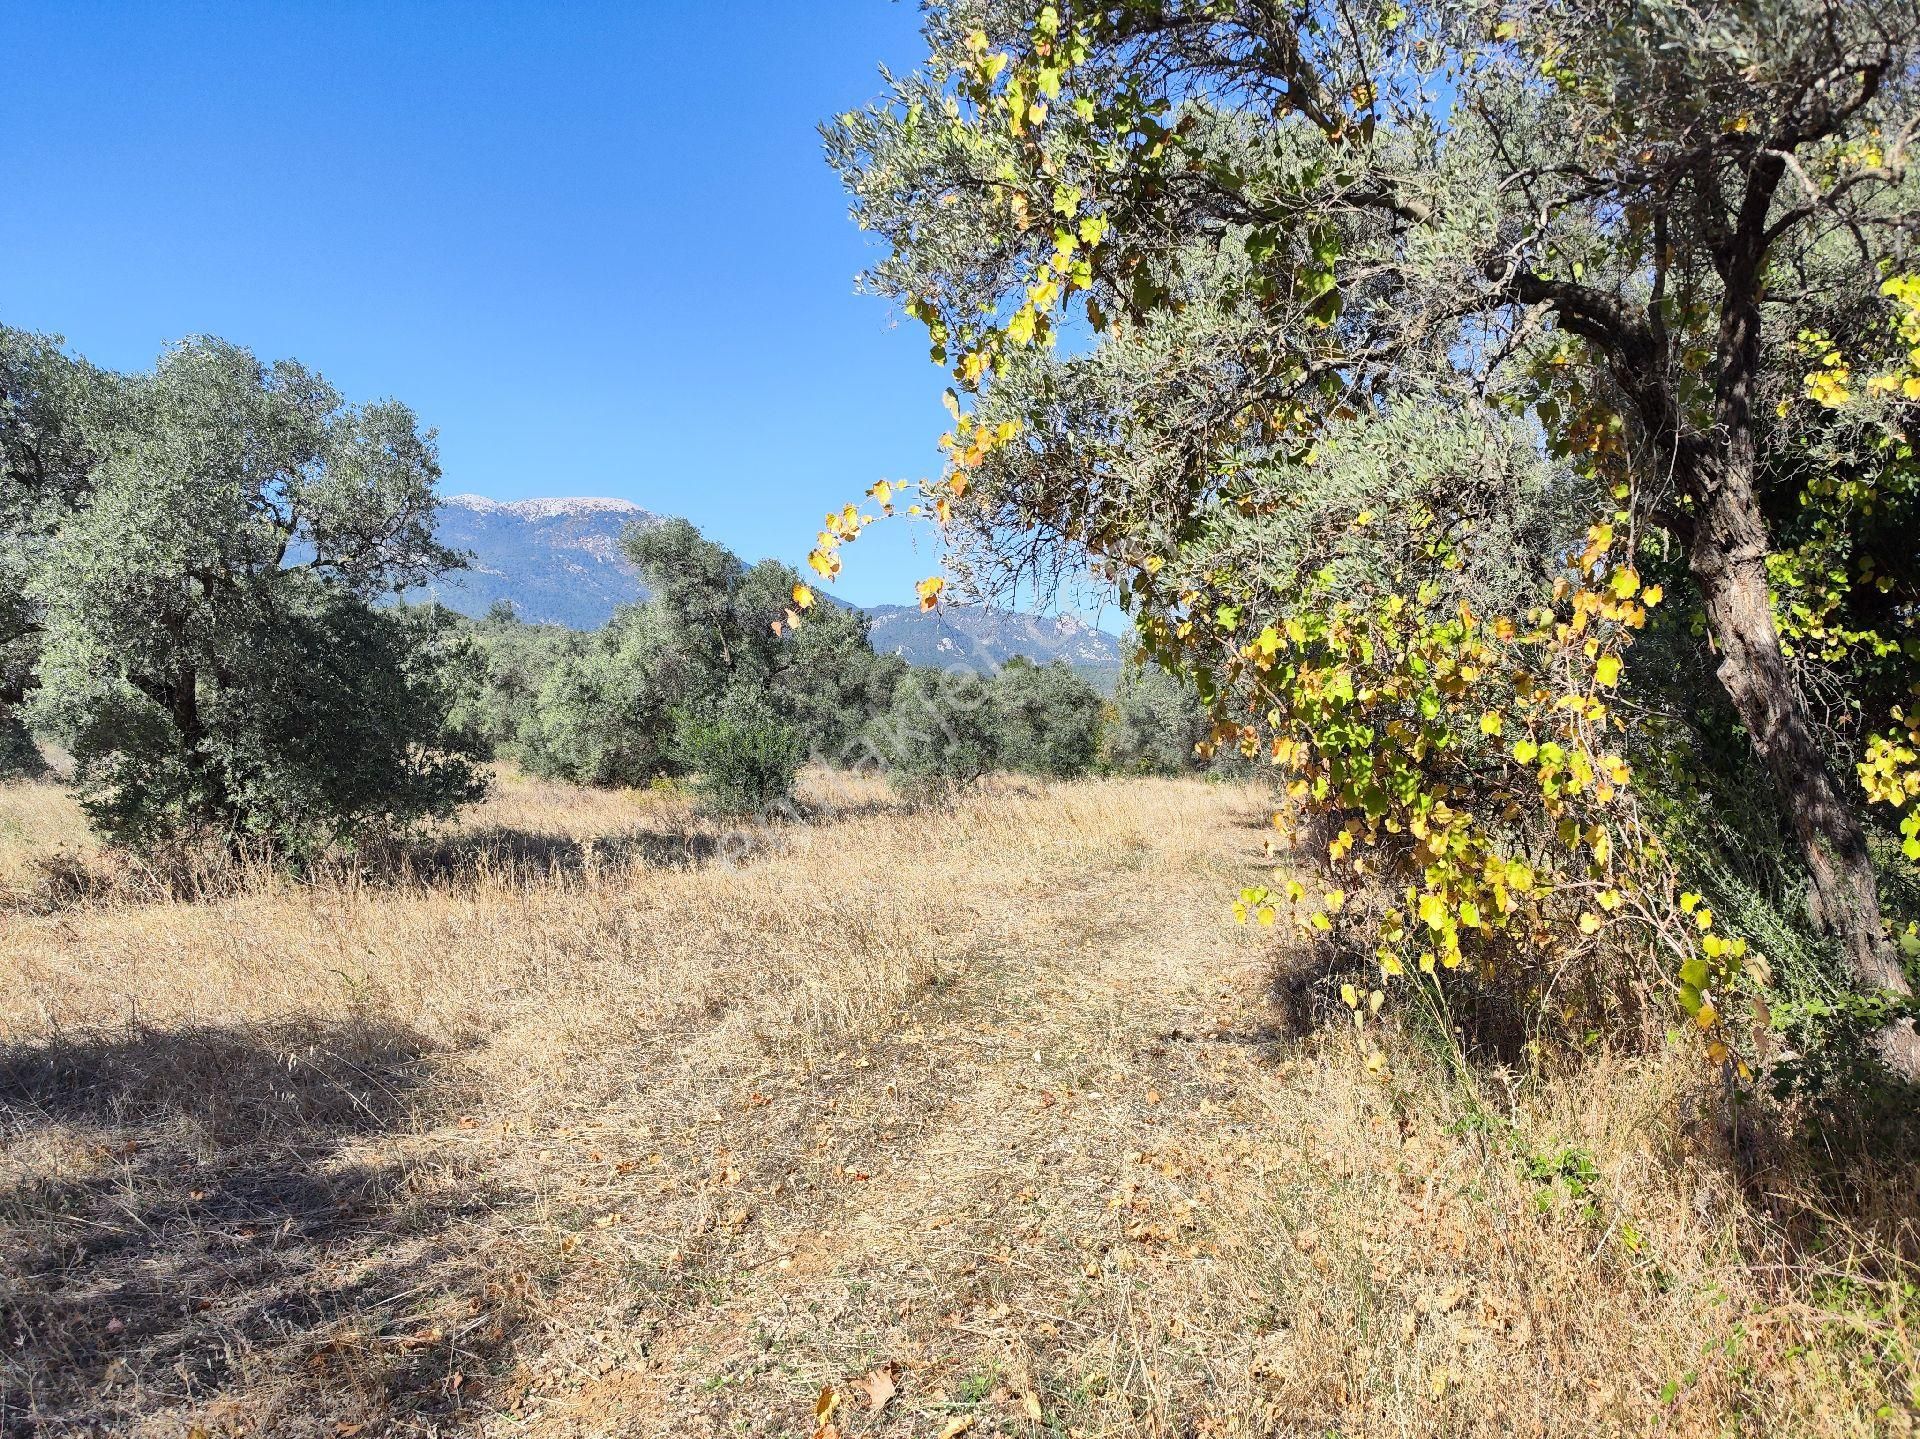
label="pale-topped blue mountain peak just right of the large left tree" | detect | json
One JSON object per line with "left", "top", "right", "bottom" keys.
{"left": 407, "top": 494, "right": 662, "bottom": 630}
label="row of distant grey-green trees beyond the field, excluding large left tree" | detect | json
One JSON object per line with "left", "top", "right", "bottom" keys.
{"left": 455, "top": 521, "right": 1206, "bottom": 813}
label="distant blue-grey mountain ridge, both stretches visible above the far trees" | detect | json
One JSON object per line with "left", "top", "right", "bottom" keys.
{"left": 407, "top": 494, "right": 1121, "bottom": 680}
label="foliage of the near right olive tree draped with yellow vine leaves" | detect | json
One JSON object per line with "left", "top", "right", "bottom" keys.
{"left": 833, "top": 0, "right": 1920, "bottom": 1074}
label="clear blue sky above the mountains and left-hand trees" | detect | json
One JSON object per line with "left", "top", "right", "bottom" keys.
{"left": 0, "top": 0, "right": 990, "bottom": 603}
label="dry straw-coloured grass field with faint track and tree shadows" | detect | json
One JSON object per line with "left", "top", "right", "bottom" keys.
{"left": 0, "top": 776, "right": 1920, "bottom": 1439}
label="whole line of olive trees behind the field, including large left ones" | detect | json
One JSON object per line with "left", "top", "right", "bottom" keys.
{"left": 0, "top": 327, "right": 1204, "bottom": 857}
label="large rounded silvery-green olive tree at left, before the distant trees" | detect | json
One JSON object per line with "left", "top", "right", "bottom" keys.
{"left": 27, "top": 340, "right": 480, "bottom": 853}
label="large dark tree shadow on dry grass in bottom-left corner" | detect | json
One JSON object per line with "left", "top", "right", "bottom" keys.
{"left": 0, "top": 1018, "right": 541, "bottom": 1439}
